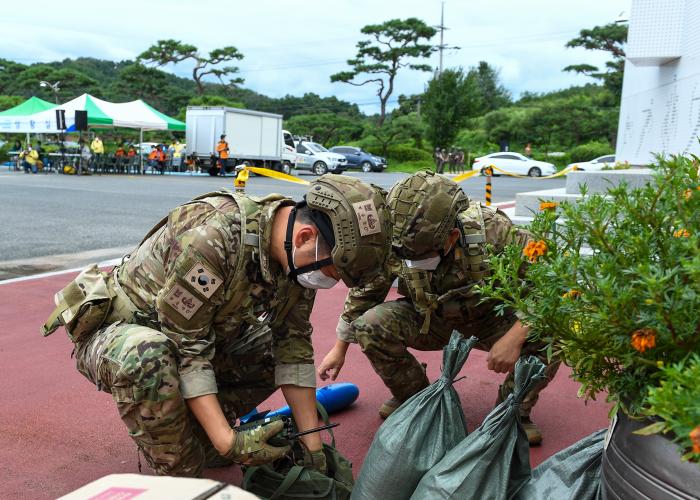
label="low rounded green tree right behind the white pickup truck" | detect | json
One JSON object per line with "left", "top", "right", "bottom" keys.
{"left": 285, "top": 113, "right": 363, "bottom": 147}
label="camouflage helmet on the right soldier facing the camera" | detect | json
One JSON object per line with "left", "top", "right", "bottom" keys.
{"left": 387, "top": 171, "right": 469, "bottom": 259}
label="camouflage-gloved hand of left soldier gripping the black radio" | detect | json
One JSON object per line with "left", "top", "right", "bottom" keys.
{"left": 223, "top": 420, "right": 291, "bottom": 465}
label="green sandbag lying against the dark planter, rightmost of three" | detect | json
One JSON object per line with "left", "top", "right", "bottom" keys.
{"left": 516, "top": 429, "right": 607, "bottom": 500}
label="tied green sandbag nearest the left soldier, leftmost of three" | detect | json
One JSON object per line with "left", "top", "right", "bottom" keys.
{"left": 351, "top": 331, "right": 477, "bottom": 500}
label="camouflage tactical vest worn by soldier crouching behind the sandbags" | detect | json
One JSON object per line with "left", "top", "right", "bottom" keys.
{"left": 400, "top": 201, "right": 490, "bottom": 335}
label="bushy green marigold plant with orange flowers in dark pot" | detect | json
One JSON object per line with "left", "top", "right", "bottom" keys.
{"left": 481, "top": 157, "right": 700, "bottom": 458}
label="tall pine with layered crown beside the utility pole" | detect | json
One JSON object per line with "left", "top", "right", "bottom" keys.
{"left": 331, "top": 17, "right": 436, "bottom": 127}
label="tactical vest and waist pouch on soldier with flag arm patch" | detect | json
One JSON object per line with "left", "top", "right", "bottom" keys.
{"left": 42, "top": 190, "right": 302, "bottom": 342}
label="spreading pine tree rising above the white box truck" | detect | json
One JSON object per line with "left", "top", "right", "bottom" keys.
{"left": 138, "top": 39, "right": 243, "bottom": 95}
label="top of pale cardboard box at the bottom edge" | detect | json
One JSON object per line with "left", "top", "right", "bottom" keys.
{"left": 61, "top": 474, "right": 258, "bottom": 500}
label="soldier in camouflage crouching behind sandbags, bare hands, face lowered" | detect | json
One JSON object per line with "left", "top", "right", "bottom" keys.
{"left": 318, "top": 172, "right": 558, "bottom": 444}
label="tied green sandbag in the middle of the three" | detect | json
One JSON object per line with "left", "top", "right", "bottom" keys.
{"left": 411, "top": 356, "right": 544, "bottom": 500}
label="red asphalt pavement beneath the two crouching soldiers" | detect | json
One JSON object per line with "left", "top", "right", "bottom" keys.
{"left": 0, "top": 274, "right": 608, "bottom": 499}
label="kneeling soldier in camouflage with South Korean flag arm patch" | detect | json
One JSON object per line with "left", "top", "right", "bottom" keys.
{"left": 43, "top": 174, "right": 390, "bottom": 476}
